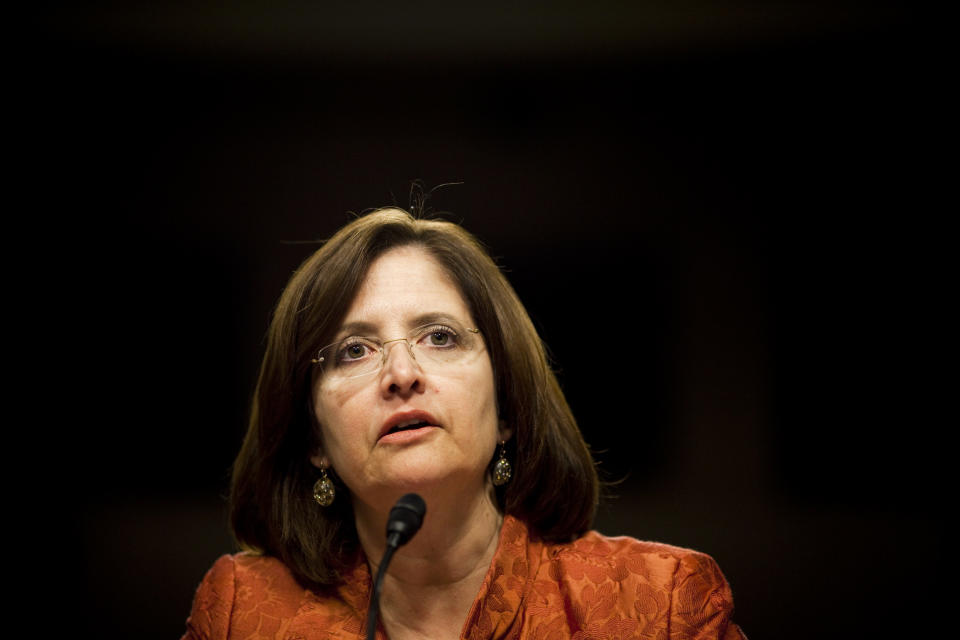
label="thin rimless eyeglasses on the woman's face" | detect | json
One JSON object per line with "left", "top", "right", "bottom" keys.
{"left": 312, "top": 321, "right": 481, "bottom": 383}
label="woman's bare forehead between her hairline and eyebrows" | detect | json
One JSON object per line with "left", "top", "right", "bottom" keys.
{"left": 342, "top": 246, "right": 471, "bottom": 329}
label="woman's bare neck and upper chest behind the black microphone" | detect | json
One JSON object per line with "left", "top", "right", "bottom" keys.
{"left": 354, "top": 491, "right": 503, "bottom": 640}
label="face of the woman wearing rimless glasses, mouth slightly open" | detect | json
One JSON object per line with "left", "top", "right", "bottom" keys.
{"left": 311, "top": 247, "right": 508, "bottom": 506}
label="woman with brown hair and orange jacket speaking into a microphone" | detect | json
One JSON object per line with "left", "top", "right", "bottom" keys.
{"left": 184, "top": 209, "right": 743, "bottom": 640}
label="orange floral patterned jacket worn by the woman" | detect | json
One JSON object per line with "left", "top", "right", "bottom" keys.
{"left": 183, "top": 516, "right": 746, "bottom": 640}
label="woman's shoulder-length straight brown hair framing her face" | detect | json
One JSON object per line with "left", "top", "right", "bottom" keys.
{"left": 230, "top": 208, "right": 599, "bottom": 585}
